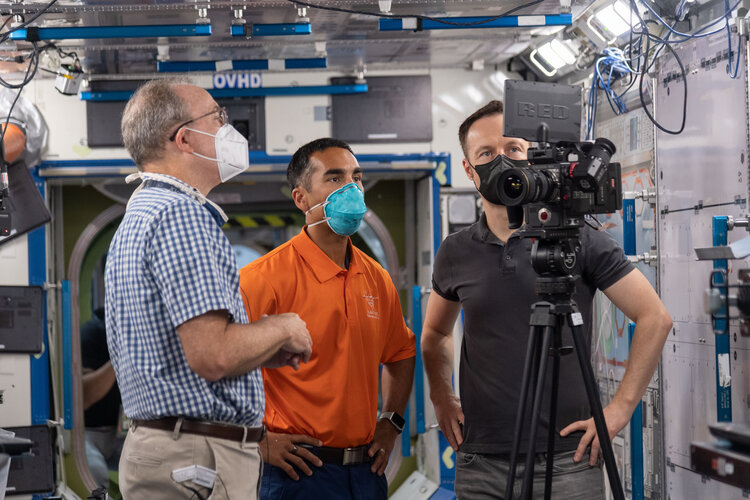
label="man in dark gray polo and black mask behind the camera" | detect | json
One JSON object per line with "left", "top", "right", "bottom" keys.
{"left": 422, "top": 101, "right": 672, "bottom": 500}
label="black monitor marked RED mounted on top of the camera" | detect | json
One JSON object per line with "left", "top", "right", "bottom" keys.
{"left": 503, "top": 80, "right": 583, "bottom": 143}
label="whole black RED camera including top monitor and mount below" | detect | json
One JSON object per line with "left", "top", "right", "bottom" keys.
{"left": 502, "top": 80, "right": 622, "bottom": 276}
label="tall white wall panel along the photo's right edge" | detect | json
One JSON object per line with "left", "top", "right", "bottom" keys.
{"left": 654, "top": 37, "right": 750, "bottom": 500}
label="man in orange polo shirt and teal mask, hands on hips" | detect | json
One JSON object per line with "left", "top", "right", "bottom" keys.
{"left": 240, "top": 138, "right": 416, "bottom": 500}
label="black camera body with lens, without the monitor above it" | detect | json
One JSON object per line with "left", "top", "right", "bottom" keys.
{"left": 496, "top": 139, "right": 622, "bottom": 239}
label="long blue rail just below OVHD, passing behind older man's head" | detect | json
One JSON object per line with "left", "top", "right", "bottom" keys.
{"left": 79, "top": 83, "right": 367, "bottom": 101}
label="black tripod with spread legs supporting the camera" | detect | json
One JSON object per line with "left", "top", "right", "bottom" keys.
{"left": 505, "top": 275, "right": 625, "bottom": 500}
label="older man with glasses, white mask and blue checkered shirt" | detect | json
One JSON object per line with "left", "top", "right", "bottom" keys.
{"left": 105, "top": 80, "right": 312, "bottom": 499}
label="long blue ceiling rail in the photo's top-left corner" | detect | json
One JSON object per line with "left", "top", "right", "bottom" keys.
{"left": 10, "top": 24, "right": 211, "bottom": 40}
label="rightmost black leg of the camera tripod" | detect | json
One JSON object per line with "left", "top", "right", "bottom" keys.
{"left": 571, "top": 324, "right": 625, "bottom": 500}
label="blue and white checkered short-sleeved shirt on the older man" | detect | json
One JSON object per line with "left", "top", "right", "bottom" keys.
{"left": 105, "top": 176, "right": 265, "bottom": 426}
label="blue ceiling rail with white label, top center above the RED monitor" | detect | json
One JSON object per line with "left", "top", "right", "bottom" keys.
{"left": 379, "top": 14, "right": 573, "bottom": 31}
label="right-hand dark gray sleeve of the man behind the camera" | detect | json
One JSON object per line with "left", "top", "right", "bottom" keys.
{"left": 581, "top": 226, "right": 635, "bottom": 290}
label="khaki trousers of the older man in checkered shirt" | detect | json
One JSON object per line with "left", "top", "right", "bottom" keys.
{"left": 120, "top": 420, "right": 263, "bottom": 500}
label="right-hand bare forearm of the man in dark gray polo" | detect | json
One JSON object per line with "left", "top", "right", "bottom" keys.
{"left": 612, "top": 315, "right": 671, "bottom": 413}
